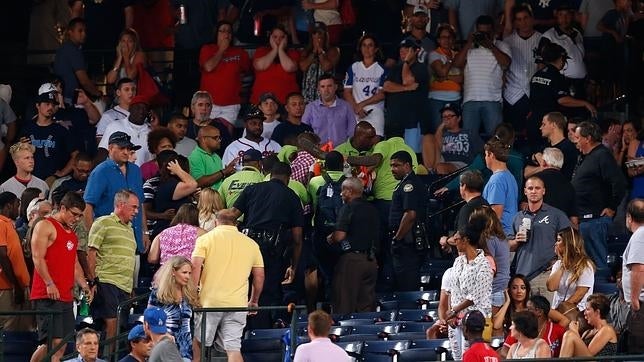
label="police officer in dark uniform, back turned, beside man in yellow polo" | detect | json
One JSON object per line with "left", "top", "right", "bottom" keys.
{"left": 232, "top": 162, "right": 304, "bottom": 329}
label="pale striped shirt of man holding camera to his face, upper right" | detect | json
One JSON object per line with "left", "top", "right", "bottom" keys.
{"left": 463, "top": 40, "right": 511, "bottom": 103}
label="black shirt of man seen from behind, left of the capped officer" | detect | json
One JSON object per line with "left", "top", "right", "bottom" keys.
{"left": 336, "top": 198, "right": 380, "bottom": 251}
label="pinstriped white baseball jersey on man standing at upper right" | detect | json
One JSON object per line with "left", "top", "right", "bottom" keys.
{"left": 503, "top": 31, "right": 541, "bottom": 105}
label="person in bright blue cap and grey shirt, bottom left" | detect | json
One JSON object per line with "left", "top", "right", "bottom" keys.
{"left": 143, "top": 307, "right": 183, "bottom": 362}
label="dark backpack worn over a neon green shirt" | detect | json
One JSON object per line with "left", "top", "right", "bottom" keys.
{"left": 315, "top": 172, "right": 346, "bottom": 236}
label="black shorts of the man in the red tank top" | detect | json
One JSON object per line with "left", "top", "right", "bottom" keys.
{"left": 34, "top": 299, "right": 76, "bottom": 343}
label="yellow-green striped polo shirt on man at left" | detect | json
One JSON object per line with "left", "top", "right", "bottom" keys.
{"left": 89, "top": 213, "right": 136, "bottom": 293}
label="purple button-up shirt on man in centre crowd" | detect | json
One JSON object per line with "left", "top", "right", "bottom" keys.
{"left": 302, "top": 97, "right": 356, "bottom": 146}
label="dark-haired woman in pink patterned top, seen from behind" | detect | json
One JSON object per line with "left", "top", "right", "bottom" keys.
{"left": 148, "top": 204, "right": 206, "bottom": 265}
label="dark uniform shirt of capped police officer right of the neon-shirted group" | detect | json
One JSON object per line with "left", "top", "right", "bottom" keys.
{"left": 389, "top": 171, "right": 427, "bottom": 229}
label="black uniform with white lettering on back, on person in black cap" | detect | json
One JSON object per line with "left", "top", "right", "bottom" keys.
{"left": 526, "top": 64, "right": 569, "bottom": 152}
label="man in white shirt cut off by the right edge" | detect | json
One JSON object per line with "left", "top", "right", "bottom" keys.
{"left": 622, "top": 198, "right": 644, "bottom": 354}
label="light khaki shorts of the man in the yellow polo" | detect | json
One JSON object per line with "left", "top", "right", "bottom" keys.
{"left": 193, "top": 312, "right": 248, "bottom": 352}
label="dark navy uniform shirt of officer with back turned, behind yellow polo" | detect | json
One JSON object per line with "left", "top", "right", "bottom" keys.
{"left": 233, "top": 179, "right": 304, "bottom": 231}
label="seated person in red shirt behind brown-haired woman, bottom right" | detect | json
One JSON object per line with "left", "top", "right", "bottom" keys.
{"left": 499, "top": 295, "right": 570, "bottom": 358}
